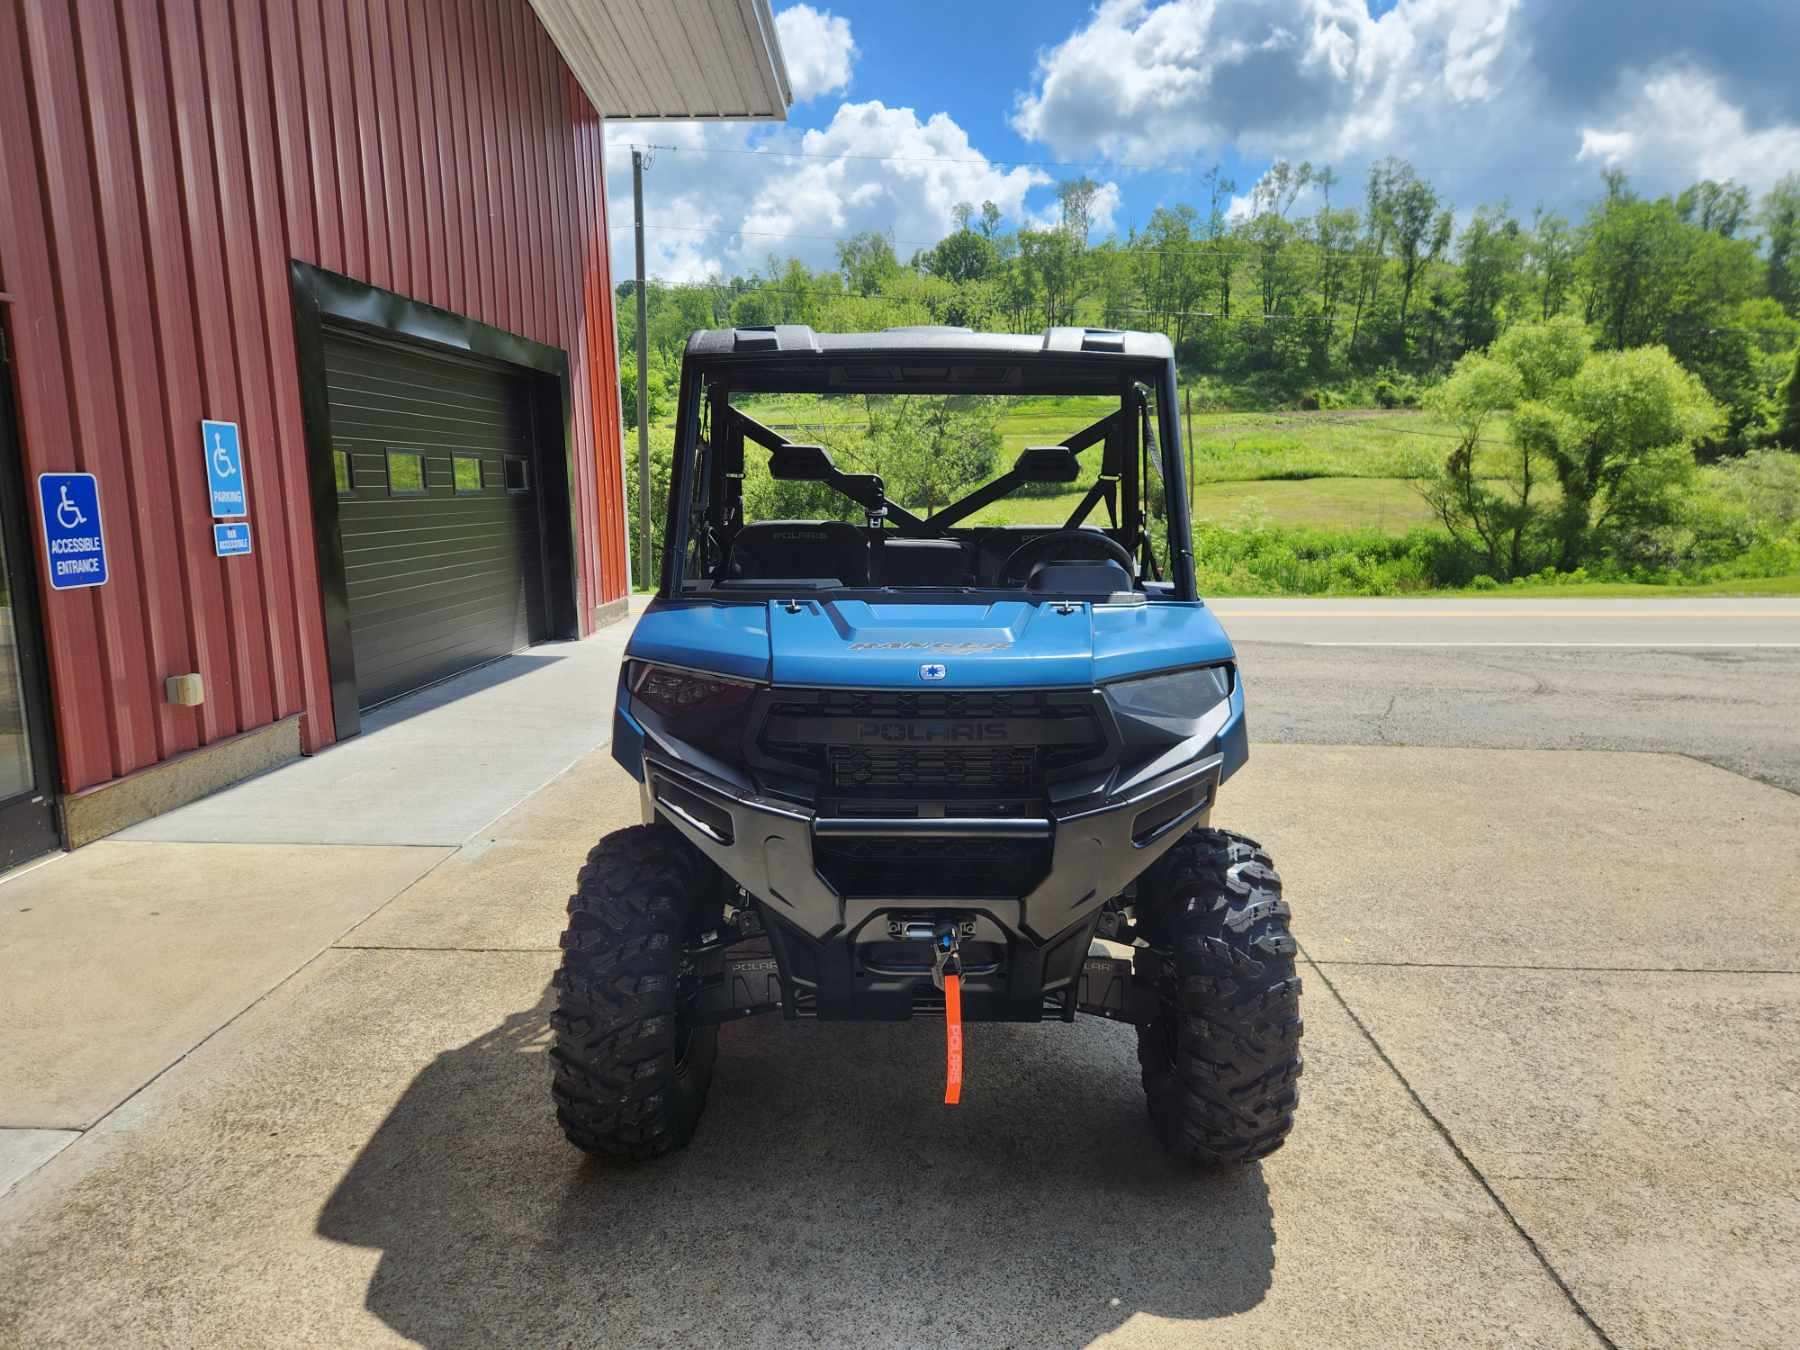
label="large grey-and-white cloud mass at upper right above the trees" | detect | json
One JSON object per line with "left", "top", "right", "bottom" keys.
{"left": 1012, "top": 0, "right": 1800, "bottom": 205}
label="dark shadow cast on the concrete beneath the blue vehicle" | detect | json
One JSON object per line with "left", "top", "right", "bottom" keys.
{"left": 319, "top": 994, "right": 1274, "bottom": 1348}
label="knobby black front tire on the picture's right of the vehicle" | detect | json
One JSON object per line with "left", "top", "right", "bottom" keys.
{"left": 1136, "top": 830, "right": 1301, "bottom": 1166}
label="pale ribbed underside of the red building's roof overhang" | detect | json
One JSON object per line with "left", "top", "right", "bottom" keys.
{"left": 531, "top": 0, "right": 794, "bottom": 122}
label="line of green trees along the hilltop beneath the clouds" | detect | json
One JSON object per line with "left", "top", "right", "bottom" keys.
{"left": 617, "top": 158, "right": 1800, "bottom": 454}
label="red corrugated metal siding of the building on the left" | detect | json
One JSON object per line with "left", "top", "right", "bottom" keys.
{"left": 0, "top": 0, "right": 625, "bottom": 790}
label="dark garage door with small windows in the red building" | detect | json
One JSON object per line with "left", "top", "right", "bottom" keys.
{"left": 324, "top": 329, "right": 545, "bottom": 707}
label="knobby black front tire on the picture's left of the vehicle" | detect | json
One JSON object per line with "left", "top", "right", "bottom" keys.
{"left": 551, "top": 824, "right": 720, "bottom": 1159}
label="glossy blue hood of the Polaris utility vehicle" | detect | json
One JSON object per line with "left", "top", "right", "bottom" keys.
{"left": 628, "top": 599, "right": 1233, "bottom": 689}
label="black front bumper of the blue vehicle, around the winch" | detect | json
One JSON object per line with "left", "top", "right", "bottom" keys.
{"left": 643, "top": 740, "right": 1224, "bottom": 1021}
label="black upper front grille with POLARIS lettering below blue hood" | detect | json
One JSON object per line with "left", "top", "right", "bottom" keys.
{"left": 758, "top": 689, "right": 1107, "bottom": 808}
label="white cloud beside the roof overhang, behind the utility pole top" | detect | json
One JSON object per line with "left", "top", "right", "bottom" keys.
{"left": 607, "top": 101, "right": 1051, "bottom": 281}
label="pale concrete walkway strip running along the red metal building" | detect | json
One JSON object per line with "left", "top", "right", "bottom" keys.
{"left": 0, "top": 603, "right": 641, "bottom": 1190}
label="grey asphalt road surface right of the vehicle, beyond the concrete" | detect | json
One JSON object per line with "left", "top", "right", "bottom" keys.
{"left": 1213, "top": 599, "right": 1800, "bottom": 792}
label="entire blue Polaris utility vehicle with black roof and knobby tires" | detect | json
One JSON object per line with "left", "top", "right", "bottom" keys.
{"left": 551, "top": 326, "right": 1301, "bottom": 1166}
